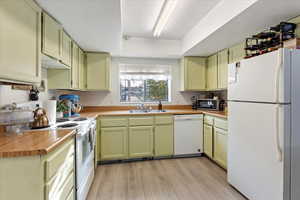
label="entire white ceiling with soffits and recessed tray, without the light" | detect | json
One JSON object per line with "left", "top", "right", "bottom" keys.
{"left": 36, "top": 0, "right": 300, "bottom": 58}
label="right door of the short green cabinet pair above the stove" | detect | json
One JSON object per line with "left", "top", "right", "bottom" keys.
{"left": 61, "top": 30, "right": 72, "bottom": 67}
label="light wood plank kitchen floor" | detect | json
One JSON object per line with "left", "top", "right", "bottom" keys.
{"left": 88, "top": 157, "right": 246, "bottom": 200}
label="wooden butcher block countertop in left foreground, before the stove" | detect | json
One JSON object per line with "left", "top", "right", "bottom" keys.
{"left": 0, "top": 129, "right": 75, "bottom": 158}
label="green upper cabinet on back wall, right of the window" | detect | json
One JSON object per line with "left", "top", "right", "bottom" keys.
{"left": 181, "top": 57, "right": 206, "bottom": 91}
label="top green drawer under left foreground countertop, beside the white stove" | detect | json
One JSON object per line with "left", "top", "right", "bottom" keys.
{"left": 45, "top": 139, "right": 74, "bottom": 182}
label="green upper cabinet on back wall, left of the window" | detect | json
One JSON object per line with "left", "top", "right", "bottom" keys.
{"left": 86, "top": 52, "right": 111, "bottom": 90}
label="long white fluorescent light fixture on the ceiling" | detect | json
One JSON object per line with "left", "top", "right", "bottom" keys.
{"left": 153, "top": 0, "right": 177, "bottom": 37}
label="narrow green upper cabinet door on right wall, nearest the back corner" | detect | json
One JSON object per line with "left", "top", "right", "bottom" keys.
{"left": 206, "top": 54, "right": 218, "bottom": 90}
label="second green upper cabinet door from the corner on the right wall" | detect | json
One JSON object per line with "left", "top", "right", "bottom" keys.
{"left": 218, "top": 49, "right": 228, "bottom": 89}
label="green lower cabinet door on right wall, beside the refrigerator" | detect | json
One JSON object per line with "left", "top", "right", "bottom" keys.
{"left": 214, "top": 127, "right": 227, "bottom": 169}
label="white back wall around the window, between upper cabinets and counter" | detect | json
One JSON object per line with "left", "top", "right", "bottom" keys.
{"left": 55, "top": 57, "right": 199, "bottom": 106}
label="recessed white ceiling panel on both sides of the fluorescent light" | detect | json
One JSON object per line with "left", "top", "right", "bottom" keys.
{"left": 121, "top": 0, "right": 220, "bottom": 40}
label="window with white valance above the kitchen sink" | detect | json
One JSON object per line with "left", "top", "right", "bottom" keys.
{"left": 120, "top": 64, "right": 171, "bottom": 103}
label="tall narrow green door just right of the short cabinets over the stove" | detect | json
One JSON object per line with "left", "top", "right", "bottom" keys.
{"left": 72, "top": 42, "right": 79, "bottom": 89}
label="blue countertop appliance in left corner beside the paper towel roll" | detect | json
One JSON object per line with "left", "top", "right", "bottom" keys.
{"left": 59, "top": 94, "right": 82, "bottom": 117}
